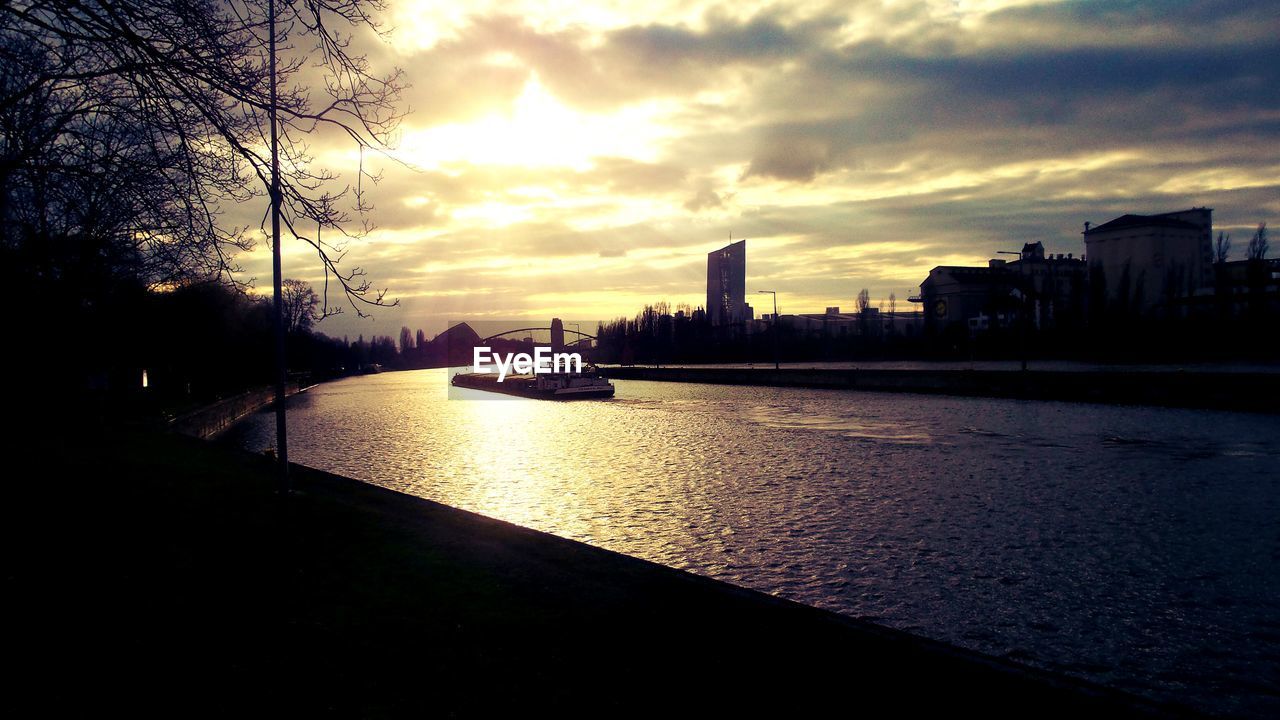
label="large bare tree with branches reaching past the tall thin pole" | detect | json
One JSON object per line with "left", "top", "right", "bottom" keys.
{"left": 0, "top": 0, "right": 402, "bottom": 315}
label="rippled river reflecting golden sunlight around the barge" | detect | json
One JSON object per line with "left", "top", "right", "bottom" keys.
{"left": 223, "top": 370, "right": 1280, "bottom": 717}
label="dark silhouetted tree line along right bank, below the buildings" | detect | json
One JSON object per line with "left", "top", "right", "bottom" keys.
{"left": 594, "top": 223, "right": 1280, "bottom": 365}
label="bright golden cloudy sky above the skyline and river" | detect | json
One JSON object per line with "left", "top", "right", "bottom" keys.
{"left": 242, "top": 0, "right": 1280, "bottom": 336}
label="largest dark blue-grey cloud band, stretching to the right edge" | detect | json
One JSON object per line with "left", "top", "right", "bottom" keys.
{"left": 749, "top": 36, "right": 1280, "bottom": 182}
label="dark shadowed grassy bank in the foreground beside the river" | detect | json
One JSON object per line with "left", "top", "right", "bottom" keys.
{"left": 4, "top": 433, "right": 1192, "bottom": 717}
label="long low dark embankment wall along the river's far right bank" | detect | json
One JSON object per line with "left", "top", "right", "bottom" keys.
{"left": 604, "top": 366, "right": 1280, "bottom": 413}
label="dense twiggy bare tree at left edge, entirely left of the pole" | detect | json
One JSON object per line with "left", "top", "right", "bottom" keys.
{"left": 0, "top": 26, "right": 251, "bottom": 292}
